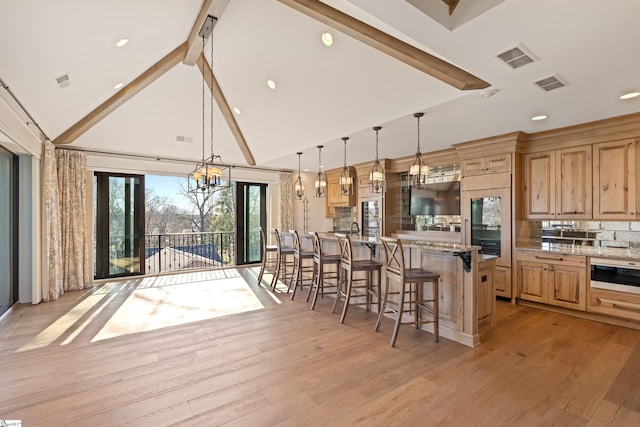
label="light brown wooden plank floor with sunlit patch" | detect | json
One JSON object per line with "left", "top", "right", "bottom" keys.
{"left": 0, "top": 269, "right": 640, "bottom": 427}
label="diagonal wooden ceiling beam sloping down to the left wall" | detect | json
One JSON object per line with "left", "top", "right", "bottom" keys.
{"left": 53, "top": 43, "right": 187, "bottom": 144}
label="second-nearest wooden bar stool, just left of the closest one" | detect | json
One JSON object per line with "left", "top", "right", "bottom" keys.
{"left": 331, "top": 233, "right": 382, "bottom": 323}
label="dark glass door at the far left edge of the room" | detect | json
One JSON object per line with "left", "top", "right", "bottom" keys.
{"left": 0, "top": 147, "right": 18, "bottom": 314}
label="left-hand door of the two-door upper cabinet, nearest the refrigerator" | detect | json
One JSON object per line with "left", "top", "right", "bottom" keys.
{"left": 523, "top": 152, "right": 555, "bottom": 219}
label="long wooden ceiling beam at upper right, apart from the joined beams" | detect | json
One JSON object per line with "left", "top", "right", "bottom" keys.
{"left": 278, "top": 0, "right": 490, "bottom": 90}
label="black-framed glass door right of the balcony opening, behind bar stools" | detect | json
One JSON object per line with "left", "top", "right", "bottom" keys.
{"left": 236, "top": 182, "right": 267, "bottom": 265}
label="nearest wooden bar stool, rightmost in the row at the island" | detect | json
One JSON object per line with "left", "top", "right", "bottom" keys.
{"left": 374, "top": 237, "right": 440, "bottom": 347}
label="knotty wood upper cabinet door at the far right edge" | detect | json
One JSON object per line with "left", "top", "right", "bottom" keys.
{"left": 593, "top": 140, "right": 636, "bottom": 219}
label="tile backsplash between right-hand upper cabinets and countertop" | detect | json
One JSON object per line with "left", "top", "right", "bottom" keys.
{"left": 518, "top": 221, "right": 640, "bottom": 249}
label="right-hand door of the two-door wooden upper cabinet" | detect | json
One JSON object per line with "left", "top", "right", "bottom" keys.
{"left": 555, "top": 146, "right": 593, "bottom": 219}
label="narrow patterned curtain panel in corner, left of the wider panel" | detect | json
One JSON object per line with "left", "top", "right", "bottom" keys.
{"left": 41, "top": 141, "right": 64, "bottom": 301}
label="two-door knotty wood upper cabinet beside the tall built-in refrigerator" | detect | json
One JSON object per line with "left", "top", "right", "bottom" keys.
{"left": 522, "top": 145, "right": 592, "bottom": 219}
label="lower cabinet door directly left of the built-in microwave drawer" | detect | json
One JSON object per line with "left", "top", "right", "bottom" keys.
{"left": 549, "top": 264, "right": 587, "bottom": 311}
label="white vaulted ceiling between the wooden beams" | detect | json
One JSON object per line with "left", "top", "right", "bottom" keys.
{"left": 0, "top": 0, "right": 640, "bottom": 170}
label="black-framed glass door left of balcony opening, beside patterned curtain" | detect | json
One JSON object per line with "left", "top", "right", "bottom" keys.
{"left": 94, "top": 172, "right": 145, "bottom": 279}
